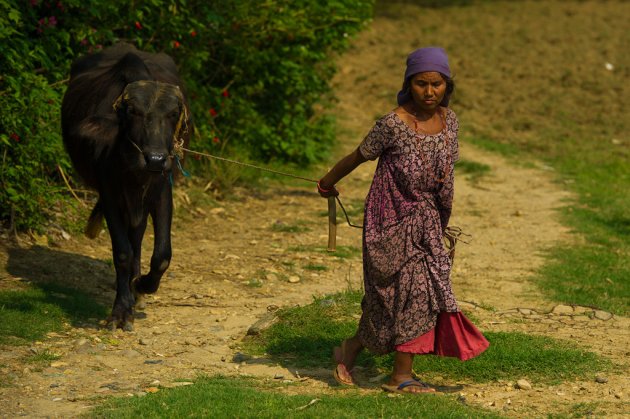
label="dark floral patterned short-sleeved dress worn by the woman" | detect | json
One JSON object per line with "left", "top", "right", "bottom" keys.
{"left": 358, "top": 108, "right": 487, "bottom": 360}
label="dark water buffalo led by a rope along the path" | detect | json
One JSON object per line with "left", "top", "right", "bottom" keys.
{"left": 61, "top": 43, "right": 192, "bottom": 330}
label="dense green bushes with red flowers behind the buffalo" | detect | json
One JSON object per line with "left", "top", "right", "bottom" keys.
{"left": 0, "top": 0, "right": 373, "bottom": 229}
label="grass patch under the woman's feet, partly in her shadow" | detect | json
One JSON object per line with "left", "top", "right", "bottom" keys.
{"left": 245, "top": 291, "right": 612, "bottom": 383}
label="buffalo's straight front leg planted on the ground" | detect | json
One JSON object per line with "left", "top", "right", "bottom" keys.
{"left": 104, "top": 200, "right": 135, "bottom": 331}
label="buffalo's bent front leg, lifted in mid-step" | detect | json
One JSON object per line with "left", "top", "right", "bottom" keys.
{"left": 135, "top": 185, "right": 173, "bottom": 294}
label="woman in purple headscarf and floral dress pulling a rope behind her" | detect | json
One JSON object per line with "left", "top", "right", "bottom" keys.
{"left": 318, "top": 47, "right": 488, "bottom": 394}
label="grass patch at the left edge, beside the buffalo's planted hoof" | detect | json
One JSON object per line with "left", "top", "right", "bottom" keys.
{"left": 0, "top": 284, "right": 107, "bottom": 345}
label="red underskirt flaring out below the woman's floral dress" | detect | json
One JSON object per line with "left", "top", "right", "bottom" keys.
{"left": 396, "top": 312, "right": 490, "bottom": 361}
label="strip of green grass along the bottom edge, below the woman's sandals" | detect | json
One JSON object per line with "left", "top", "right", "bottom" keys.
{"left": 86, "top": 377, "right": 500, "bottom": 419}
